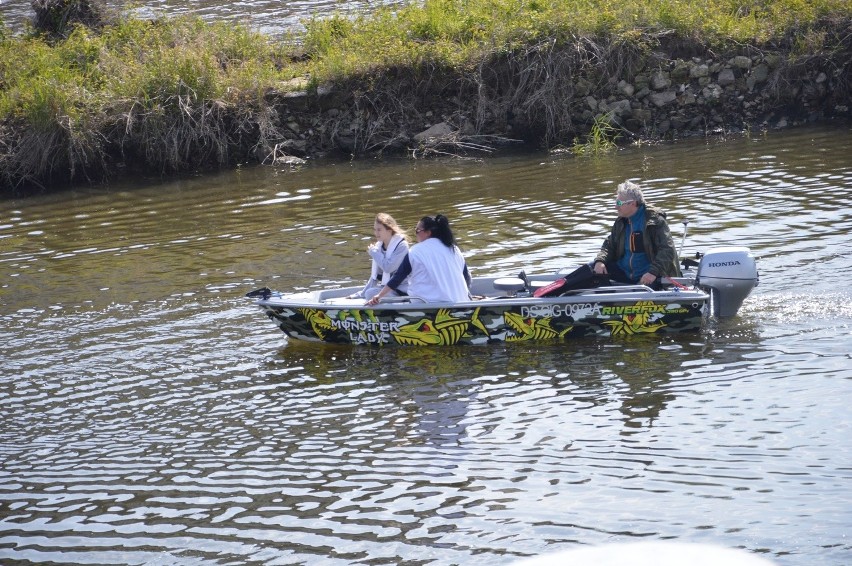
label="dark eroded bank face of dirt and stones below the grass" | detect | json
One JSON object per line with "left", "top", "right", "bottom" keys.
{"left": 0, "top": 20, "right": 852, "bottom": 195}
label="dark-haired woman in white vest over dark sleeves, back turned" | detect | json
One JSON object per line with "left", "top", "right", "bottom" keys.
{"left": 367, "top": 214, "right": 471, "bottom": 305}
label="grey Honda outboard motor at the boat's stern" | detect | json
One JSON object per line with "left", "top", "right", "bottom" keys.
{"left": 695, "top": 246, "right": 760, "bottom": 317}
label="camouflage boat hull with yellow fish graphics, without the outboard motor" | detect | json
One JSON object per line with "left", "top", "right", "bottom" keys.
{"left": 250, "top": 278, "right": 709, "bottom": 346}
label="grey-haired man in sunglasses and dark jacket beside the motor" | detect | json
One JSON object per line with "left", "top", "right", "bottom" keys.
{"left": 535, "top": 181, "right": 681, "bottom": 297}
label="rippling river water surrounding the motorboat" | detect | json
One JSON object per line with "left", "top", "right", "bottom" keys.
{"left": 0, "top": 127, "right": 852, "bottom": 566}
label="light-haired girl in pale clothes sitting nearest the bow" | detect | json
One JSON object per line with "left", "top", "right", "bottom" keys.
{"left": 349, "top": 212, "right": 409, "bottom": 299}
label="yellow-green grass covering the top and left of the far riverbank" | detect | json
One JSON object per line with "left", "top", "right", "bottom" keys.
{"left": 0, "top": 0, "right": 852, "bottom": 193}
